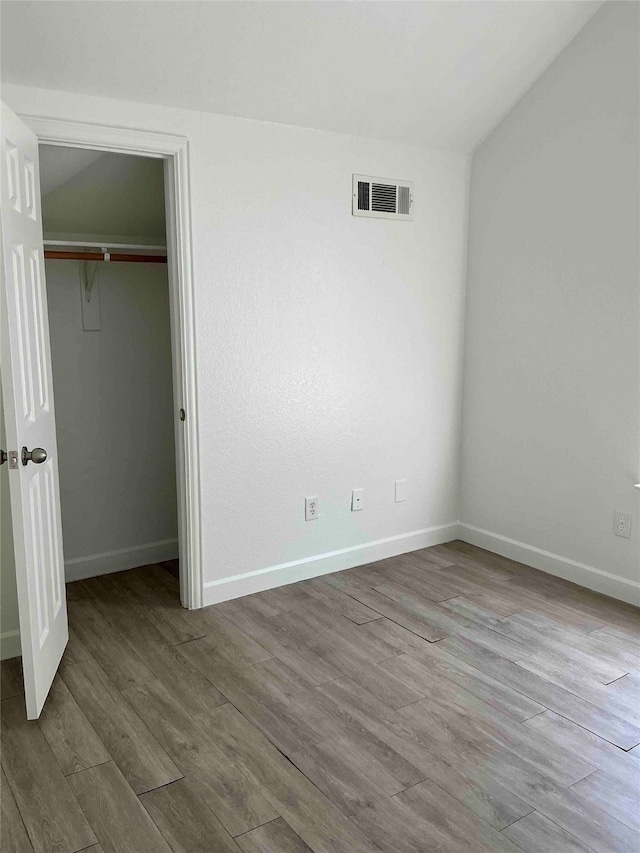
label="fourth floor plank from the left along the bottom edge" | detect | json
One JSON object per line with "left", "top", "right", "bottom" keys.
{"left": 140, "top": 779, "right": 240, "bottom": 853}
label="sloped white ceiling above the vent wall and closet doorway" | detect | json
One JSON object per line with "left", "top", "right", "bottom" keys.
{"left": 1, "top": 0, "right": 601, "bottom": 151}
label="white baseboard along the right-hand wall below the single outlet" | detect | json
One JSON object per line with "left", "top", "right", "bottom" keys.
{"left": 458, "top": 522, "right": 640, "bottom": 605}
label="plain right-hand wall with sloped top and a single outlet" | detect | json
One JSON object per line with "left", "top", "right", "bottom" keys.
{"left": 461, "top": 2, "right": 640, "bottom": 602}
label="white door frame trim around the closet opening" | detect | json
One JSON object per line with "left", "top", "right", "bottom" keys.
{"left": 19, "top": 113, "right": 203, "bottom": 610}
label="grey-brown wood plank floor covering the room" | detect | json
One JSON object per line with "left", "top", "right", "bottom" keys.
{"left": 0, "top": 542, "right": 640, "bottom": 853}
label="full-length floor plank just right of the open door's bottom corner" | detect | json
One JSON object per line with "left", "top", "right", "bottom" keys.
{"left": 63, "top": 660, "right": 183, "bottom": 794}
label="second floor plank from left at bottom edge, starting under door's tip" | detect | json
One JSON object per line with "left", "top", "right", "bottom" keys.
{"left": 1, "top": 697, "right": 97, "bottom": 853}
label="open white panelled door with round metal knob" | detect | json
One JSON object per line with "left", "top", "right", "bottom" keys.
{"left": 0, "top": 104, "right": 68, "bottom": 719}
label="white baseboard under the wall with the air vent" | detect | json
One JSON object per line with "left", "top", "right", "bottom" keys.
{"left": 203, "top": 523, "right": 458, "bottom": 607}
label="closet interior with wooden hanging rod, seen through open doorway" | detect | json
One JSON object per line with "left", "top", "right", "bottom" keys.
{"left": 40, "top": 146, "right": 178, "bottom": 582}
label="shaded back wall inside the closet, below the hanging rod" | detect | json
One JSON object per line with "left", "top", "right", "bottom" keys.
{"left": 45, "top": 261, "right": 178, "bottom": 580}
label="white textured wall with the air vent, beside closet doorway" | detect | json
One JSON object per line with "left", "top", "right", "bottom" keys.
{"left": 3, "top": 85, "right": 468, "bottom": 601}
